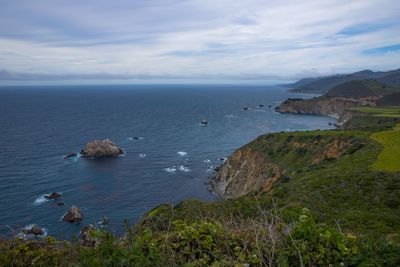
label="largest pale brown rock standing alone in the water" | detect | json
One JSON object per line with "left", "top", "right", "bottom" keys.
{"left": 81, "top": 139, "right": 124, "bottom": 159}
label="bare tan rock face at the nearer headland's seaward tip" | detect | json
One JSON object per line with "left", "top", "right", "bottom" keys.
{"left": 212, "top": 148, "right": 281, "bottom": 198}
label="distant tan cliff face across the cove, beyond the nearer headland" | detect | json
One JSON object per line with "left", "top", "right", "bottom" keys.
{"left": 276, "top": 97, "right": 363, "bottom": 118}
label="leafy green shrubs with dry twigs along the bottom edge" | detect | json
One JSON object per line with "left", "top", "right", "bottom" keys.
{"left": 0, "top": 207, "right": 400, "bottom": 266}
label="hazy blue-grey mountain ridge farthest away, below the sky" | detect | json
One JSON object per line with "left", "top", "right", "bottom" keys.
{"left": 286, "top": 69, "right": 400, "bottom": 94}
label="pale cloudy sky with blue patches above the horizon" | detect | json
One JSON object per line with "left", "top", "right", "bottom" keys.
{"left": 0, "top": 0, "right": 400, "bottom": 85}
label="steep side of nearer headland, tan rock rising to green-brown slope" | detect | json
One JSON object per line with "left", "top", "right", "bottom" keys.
{"left": 211, "top": 132, "right": 365, "bottom": 198}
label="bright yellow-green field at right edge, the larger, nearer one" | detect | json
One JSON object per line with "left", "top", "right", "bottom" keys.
{"left": 371, "top": 124, "right": 400, "bottom": 171}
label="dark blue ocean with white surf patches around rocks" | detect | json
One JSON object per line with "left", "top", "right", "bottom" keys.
{"left": 0, "top": 85, "right": 335, "bottom": 239}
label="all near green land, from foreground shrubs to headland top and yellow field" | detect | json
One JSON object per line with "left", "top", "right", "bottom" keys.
{"left": 0, "top": 110, "right": 400, "bottom": 266}
